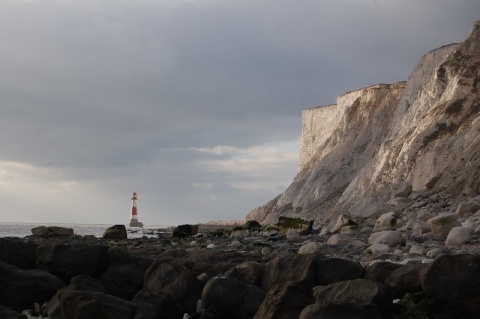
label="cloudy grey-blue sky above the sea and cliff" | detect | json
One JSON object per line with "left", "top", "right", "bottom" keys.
{"left": 0, "top": 0, "right": 480, "bottom": 225}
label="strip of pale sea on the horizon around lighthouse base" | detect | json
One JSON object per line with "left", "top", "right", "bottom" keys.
{"left": 0, "top": 223, "right": 172, "bottom": 238}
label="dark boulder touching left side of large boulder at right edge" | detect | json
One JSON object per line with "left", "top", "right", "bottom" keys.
{"left": 385, "top": 264, "right": 425, "bottom": 299}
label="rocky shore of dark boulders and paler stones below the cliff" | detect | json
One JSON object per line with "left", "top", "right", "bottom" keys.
{"left": 0, "top": 193, "right": 480, "bottom": 319}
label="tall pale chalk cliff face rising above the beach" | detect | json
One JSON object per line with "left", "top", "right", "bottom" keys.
{"left": 247, "top": 22, "right": 480, "bottom": 225}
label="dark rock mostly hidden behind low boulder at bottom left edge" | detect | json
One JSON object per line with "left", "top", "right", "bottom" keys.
{"left": 46, "top": 275, "right": 107, "bottom": 319}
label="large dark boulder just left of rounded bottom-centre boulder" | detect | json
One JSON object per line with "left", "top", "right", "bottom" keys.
{"left": 141, "top": 260, "right": 203, "bottom": 313}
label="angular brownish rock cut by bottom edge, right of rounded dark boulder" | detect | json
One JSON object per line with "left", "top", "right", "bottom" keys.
{"left": 254, "top": 283, "right": 314, "bottom": 319}
